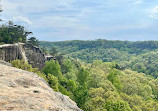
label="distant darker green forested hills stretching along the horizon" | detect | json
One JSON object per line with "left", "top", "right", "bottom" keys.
{"left": 40, "top": 39, "right": 158, "bottom": 78}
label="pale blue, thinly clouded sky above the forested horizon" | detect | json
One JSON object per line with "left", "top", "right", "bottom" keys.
{"left": 1, "top": 0, "right": 158, "bottom": 41}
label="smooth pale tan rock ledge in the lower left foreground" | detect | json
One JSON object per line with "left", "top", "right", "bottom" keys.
{"left": 0, "top": 64, "right": 82, "bottom": 111}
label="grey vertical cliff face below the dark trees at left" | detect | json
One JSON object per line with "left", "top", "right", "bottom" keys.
{"left": 0, "top": 43, "right": 45, "bottom": 69}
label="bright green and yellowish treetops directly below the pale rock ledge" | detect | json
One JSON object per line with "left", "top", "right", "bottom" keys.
{"left": 11, "top": 59, "right": 158, "bottom": 111}
